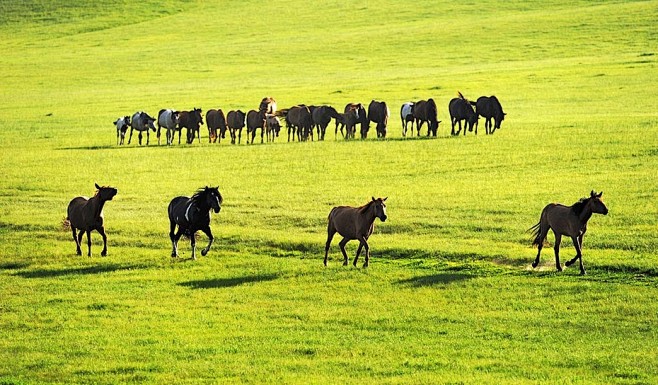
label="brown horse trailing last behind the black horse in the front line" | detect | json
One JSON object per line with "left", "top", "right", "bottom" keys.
{"left": 66, "top": 184, "right": 117, "bottom": 257}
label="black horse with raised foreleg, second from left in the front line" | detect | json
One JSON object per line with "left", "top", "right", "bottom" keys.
{"left": 167, "top": 186, "right": 224, "bottom": 259}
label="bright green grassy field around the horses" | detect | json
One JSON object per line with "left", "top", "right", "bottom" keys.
{"left": 0, "top": 0, "right": 658, "bottom": 385}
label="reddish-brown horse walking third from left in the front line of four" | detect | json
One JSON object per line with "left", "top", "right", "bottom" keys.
{"left": 324, "top": 197, "right": 387, "bottom": 267}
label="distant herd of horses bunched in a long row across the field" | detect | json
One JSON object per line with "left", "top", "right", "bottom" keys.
{"left": 113, "top": 92, "right": 506, "bottom": 145}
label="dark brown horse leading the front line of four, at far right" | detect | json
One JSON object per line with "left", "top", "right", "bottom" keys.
{"left": 530, "top": 191, "right": 608, "bottom": 275}
